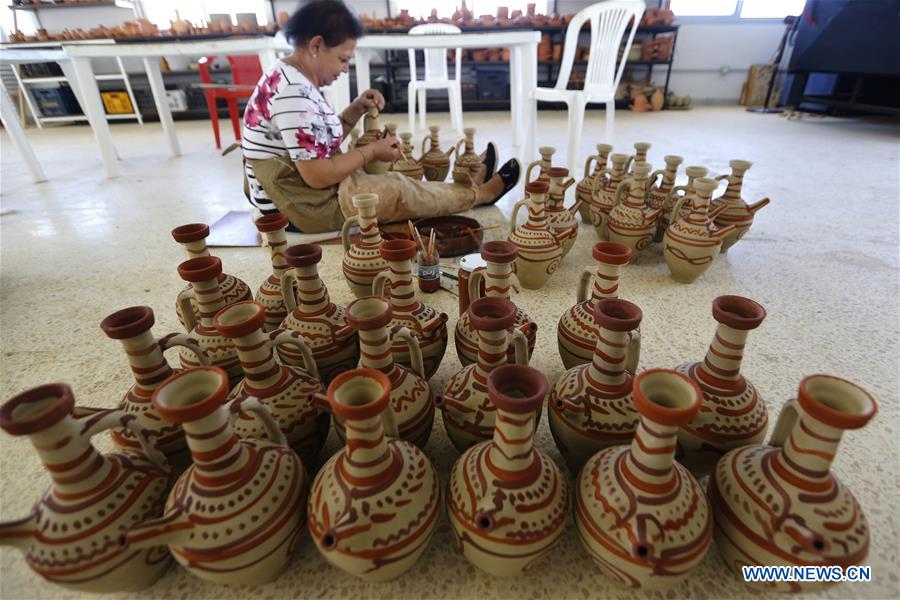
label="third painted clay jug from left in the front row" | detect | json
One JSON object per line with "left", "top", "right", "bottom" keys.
{"left": 309, "top": 366, "right": 441, "bottom": 581}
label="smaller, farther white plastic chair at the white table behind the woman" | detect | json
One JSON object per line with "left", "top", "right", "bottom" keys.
{"left": 407, "top": 23, "right": 463, "bottom": 136}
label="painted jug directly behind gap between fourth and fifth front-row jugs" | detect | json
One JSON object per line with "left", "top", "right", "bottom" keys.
{"left": 547, "top": 298, "right": 643, "bottom": 473}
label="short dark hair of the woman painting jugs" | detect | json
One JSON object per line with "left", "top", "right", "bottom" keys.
{"left": 284, "top": 0, "right": 365, "bottom": 48}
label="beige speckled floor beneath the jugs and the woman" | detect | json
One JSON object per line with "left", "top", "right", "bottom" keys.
{"left": 0, "top": 108, "right": 900, "bottom": 598}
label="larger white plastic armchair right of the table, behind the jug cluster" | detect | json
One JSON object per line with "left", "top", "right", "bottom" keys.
{"left": 528, "top": 0, "right": 644, "bottom": 173}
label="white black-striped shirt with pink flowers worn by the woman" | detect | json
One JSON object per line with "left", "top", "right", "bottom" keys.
{"left": 241, "top": 60, "right": 343, "bottom": 214}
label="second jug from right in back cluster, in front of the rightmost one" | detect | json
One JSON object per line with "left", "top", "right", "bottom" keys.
{"left": 663, "top": 177, "right": 734, "bottom": 283}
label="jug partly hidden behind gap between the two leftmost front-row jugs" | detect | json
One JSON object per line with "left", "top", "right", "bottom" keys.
{"left": 100, "top": 306, "right": 209, "bottom": 470}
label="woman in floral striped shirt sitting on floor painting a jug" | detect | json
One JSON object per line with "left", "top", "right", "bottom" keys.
{"left": 242, "top": 0, "right": 521, "bottom": 233}
